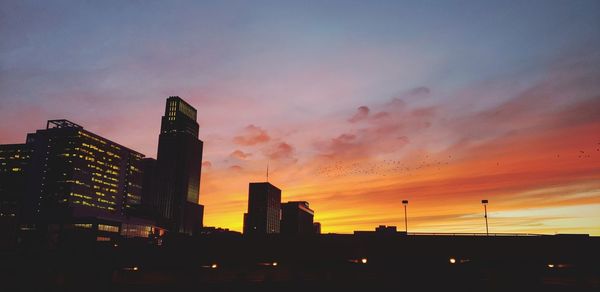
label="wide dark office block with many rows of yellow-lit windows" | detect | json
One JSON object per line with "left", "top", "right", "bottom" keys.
{"left": 23, "top": 120, "right": 144, "bottom": 221}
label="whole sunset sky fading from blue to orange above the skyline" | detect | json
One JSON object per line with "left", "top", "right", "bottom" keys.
{"left": 0, "top": 0, "right": 600, "bottom": 235}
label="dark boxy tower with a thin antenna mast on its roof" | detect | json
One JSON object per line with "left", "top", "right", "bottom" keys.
{"left": 244, "top": 182, "right": 281, "bottom": 235}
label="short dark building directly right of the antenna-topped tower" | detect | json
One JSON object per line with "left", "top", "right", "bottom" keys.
{"left": 281, "top": 201, "right": 315, "bottom": 235}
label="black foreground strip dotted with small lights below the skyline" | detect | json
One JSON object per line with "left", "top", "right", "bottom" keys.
{"left": 0, "top": 235, "right": 600, "bottom": 291}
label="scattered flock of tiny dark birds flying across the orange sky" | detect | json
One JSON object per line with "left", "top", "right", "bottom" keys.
{"left": 316, "top": 142, "right": 600, "bottom": 177}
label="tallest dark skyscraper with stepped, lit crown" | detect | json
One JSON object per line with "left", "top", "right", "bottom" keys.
{"left": 154, "top": 96, "right": 204, "bottom": 234}
